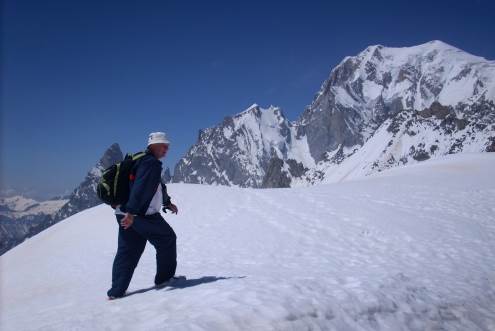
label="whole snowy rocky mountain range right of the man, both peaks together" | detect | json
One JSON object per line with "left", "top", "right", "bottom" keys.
{"left": 173, "top": 41, "right": 495, "bottom": 187}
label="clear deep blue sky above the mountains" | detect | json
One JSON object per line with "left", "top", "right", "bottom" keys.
{"left": 1, "top": 0, "right": 495, "bottom": 197}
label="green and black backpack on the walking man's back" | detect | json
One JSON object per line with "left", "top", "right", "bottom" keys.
{"left": 96, "top": 152, "right": 146, "bottom": 208}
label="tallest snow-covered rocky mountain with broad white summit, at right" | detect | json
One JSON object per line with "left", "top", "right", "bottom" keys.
{"left": 298, "top": 41, "right": 495, "bottom": 181}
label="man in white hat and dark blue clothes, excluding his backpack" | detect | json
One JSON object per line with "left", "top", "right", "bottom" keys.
{"left": 107, "top": 132, "right": 178, "bottom": 299}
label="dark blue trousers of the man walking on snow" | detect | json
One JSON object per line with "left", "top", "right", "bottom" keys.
{"left": 107, "top": 214, "right": 177, "bottom": 297}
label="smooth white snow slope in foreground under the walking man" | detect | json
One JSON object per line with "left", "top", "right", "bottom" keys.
{"left": 0, "top": 153, "right": 495, "bottom": 330}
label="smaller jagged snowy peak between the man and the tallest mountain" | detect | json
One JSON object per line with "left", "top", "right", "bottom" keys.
{"left": 173, "top": 104, "right": 306, "bottom": 187}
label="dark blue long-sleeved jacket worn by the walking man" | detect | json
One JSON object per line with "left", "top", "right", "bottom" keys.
{"left": 121, "top": 151, "right": 170, "bottom": 216}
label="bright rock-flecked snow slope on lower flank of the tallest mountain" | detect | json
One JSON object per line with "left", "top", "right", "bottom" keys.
{"left": 304, "top": 108, "right": 495, "bottom": 186}
